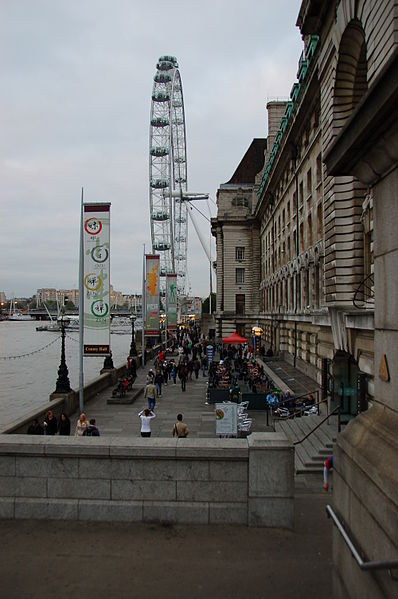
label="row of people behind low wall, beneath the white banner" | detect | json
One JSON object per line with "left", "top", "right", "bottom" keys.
{"left": 27, "top": 410, "right": 100, "bottom": 437}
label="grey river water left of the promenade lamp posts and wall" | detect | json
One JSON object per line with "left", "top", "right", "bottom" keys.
{"left": 0, "top": 320, "right": 136, "bottom": 427}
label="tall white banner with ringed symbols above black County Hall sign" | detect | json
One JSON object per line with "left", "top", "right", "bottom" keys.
{"left": 82, "top": 203, "right": 111, "bottom": 356}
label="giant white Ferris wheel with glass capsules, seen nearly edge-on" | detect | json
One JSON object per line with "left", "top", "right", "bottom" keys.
{"left": 149, "top": 56, "right": 188, "bottom": 295}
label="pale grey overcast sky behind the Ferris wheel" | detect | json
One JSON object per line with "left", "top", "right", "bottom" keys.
{"left": 0, "top": 0, "right": 302, "bottom": 297}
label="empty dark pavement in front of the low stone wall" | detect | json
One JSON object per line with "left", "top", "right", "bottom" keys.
{"left": 0, "top": 485, "right": 332, "bottom": 599}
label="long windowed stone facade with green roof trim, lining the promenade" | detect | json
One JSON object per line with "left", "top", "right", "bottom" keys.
{"left": 253, "top": 2, "right": 376, "bottom": 419}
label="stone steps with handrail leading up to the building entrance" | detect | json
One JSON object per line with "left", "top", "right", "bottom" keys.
{"left": 275, "top": 414, "right": 337, "bottom": 474}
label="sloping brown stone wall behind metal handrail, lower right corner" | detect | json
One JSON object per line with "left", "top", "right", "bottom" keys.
{"left": 333, "top": 403, "right": 398, "bottom": 599}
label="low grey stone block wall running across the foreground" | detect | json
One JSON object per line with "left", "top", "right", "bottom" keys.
{"left": 0, "top": 433, "right": 294, "bottom": 528}
